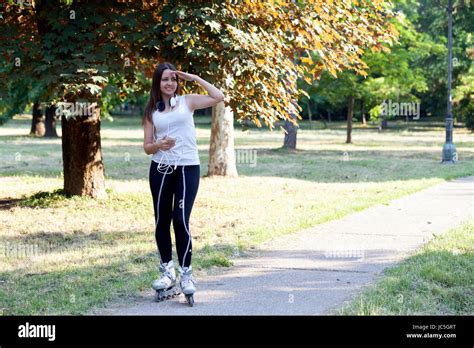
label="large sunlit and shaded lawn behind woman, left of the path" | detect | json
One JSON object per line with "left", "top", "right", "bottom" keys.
{"left": 0, "top": 117, "right": 474, "bottom": 315}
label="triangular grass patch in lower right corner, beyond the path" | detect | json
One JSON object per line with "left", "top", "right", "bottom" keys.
{"left": 339, "top": 220, "right": 474, "bottom": 315}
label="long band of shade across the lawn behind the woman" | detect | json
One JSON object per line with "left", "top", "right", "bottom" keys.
{"left": 3, "top": 148, "right": 474, "bottom": 183}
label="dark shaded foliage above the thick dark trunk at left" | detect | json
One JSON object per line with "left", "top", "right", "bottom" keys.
{"left": 0, "top": 0, "right": 159, "bottom": 122}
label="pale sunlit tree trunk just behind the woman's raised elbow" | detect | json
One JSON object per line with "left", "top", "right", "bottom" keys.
{"left": 207, "top": 102, "right": 238, "bottom": 176}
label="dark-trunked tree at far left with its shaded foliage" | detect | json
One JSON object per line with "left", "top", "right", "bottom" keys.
{"left": 0, "top": 0, "right": 159, "bottom": 197}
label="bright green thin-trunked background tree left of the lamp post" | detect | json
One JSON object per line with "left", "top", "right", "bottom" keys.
{"left": 304, "top": 0, "right": 445, "bottom": 142}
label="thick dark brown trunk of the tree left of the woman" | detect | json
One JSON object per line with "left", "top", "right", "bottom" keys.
{"left": 61, "top": 103, "right": 106, "bottom": 199}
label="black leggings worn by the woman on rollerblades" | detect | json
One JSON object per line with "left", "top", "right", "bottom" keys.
{"left": 149, "top": 161, "right": 200, "bottom": 267}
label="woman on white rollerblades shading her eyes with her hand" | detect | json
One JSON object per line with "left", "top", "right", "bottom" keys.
{"left": 143, "top": 63, "right": 224, "bottom": 306}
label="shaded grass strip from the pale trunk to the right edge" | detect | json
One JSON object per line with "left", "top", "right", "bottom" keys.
{"left": 237, "top": 148, "right": 474, "bottom": 183}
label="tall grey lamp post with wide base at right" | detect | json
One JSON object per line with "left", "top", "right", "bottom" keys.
{"left": 441, "top": 0, "right": 458, "bottom": 163}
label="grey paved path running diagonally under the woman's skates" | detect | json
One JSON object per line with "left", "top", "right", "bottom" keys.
{"left": 94, "top": 176, "right": 474, "bottom": 315}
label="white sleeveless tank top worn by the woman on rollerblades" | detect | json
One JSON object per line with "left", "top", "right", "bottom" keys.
{"left": 151, "top": 95, "right": 200, "bottom": 166}
